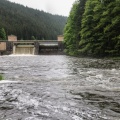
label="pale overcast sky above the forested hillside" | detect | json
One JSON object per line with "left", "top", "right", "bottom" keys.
{"left": 9, "top": 0, "right": 75, "bottom": 16}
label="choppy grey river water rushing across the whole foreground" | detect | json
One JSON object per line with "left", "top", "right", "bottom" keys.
{"left": 0, "top": 55, "right": 120, "bottom": 120}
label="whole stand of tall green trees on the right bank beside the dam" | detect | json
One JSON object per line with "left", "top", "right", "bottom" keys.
{"left": 64, "top": 0, "right": 120, "bottom": 57}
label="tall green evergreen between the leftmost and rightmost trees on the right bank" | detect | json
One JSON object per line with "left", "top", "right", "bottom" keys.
{"left": 79, "top": 0, "right": 100, "bottom": 55}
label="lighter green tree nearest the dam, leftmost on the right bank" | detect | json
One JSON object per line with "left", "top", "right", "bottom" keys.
{"left": 64, "top": 0, "right": 86, "bottom": 55}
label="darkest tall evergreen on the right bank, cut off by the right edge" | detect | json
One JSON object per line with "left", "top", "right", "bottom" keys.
{"left": 103, "top": 0, "right": 120, "bottom": 56}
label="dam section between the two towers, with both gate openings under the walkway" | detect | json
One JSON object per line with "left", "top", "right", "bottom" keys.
{"left": 12, "top": 40, "right": 63, "bottom": 55}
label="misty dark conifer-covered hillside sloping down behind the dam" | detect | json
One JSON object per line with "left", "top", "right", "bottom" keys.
{"left": 0, "top": 0, "right": 67, "bottom": 40}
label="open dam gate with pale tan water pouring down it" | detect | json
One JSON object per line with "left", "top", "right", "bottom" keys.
{"left": 13, "top": 45, "right": 35, "bottom": 55}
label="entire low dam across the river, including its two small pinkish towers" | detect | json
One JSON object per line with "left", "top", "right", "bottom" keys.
{"left": 0, "top": 35, "right": 64, "bottom": 55}
